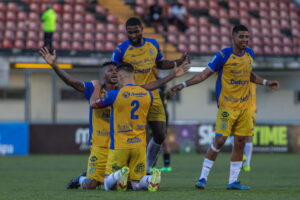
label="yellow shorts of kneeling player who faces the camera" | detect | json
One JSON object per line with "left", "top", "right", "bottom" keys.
{"left": 86, "top": 145, "right": 108, "bottom": 183}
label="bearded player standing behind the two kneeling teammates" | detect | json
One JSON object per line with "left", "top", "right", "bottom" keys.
{"left": 112, "top": 17, "right": 189, "bottom": 172}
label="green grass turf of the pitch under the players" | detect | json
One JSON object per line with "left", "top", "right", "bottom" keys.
{"left": 0, "top": 154, "right": 300, "bottom": 200}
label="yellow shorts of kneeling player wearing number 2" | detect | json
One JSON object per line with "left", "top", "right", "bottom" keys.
{"left": 105, "top": 147, "right": 146, "bottom": 181}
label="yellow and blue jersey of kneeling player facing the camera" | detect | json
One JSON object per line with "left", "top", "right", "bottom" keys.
{"left": 84, "top": 82, "right": 111, "bottom": 148}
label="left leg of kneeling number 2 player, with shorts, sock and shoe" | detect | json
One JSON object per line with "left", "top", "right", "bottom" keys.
{"left": 104, "top": 149, "right": 130, "bottom": 191}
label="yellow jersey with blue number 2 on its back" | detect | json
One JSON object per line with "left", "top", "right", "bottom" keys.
{"left": 97, "top": 84, "right": 153, "bottom": 149}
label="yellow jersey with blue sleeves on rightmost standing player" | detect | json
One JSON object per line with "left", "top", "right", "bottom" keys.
{"left": 208, "top": 48, "right": 254, "bottom": 109}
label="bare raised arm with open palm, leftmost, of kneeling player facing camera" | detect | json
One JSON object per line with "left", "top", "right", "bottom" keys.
{"left": 40, "top": 47, "right": 84, "bottom": 92}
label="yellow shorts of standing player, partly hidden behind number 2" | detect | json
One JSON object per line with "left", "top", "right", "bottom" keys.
{"left": 148, "top": 94, "right": 166, "bottom": 122}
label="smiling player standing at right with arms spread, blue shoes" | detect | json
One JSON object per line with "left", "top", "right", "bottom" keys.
{"left": 172, "top": 25, "right": 279, "bottom": 190}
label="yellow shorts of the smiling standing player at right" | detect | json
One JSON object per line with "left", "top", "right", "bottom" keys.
{"left": 216, "top": 108, "right": 254, "bottom": 136}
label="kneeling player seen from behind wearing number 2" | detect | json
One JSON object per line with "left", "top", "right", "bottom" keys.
{"left": 91, "top": 63, "right": 189, "bottom": 191}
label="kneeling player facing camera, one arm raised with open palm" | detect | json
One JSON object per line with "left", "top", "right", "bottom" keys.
{"left": 40, "top": 48, "right": 117, "bottom": 189}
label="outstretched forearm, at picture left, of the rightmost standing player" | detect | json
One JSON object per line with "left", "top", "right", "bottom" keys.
{"left": 171, "top": 67, "right": 213, "bottom": 95}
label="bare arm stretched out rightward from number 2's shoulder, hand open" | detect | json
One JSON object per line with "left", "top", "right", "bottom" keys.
{"left": 142, "top": 61, "right": 190, "bottom": 90}
